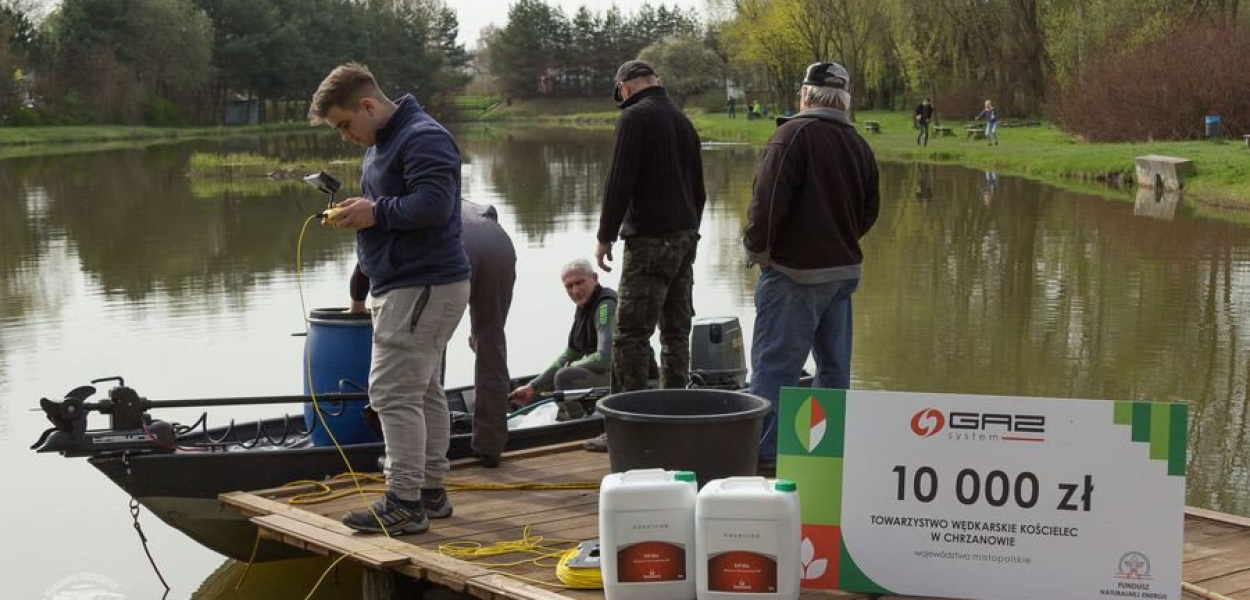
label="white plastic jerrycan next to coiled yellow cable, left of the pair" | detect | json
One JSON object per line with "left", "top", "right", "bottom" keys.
{"left": 599, "top": 469, "right": 698, "bottom": 600}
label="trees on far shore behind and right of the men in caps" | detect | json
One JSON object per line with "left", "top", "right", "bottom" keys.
{"left": 483, "top": 0, "right": 1250, "bottom": 135}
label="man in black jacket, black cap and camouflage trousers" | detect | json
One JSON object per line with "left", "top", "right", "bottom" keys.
{"left": 588, "top": 60, "right": 706, "bottom": 450}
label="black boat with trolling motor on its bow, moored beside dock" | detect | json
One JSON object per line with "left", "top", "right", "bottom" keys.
{"left": 31, "top": 378, "right": 606, "bottom": 561}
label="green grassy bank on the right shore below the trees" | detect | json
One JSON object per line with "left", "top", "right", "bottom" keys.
{"left": 691, "top": 111, "right": 1250, "bottom": 216}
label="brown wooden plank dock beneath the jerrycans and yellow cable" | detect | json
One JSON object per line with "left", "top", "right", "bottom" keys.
{"left": 221, "top": 444, "right": 1250, "bottom": 600}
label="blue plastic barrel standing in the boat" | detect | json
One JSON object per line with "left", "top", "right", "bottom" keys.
{"left": 300, "top": 309, "right": 381, "bottom": 446}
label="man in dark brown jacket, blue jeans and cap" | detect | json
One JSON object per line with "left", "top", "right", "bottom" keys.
{"left": 743, "top": 63, "right": 880, "bottom": 470}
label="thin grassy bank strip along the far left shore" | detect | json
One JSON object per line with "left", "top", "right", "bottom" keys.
{"left": 0, "top": 123, "right": 309, "bottom": 146}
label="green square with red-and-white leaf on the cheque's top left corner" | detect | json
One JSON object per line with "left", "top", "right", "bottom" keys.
{"left": 778, "top": 388, "right": 846, "bottom": 458}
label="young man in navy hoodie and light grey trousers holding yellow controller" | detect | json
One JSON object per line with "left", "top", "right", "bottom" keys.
{"left": 309, "top": 63, "right": 470, "bottom": 534}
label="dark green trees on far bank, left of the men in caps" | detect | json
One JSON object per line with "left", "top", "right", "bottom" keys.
{"left": 0, "top": 0, "right": 469, "bottom": 125}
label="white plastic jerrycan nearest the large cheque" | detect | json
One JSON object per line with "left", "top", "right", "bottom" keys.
{"left": 695, "top": 478, "right": 803, "bottom": 600}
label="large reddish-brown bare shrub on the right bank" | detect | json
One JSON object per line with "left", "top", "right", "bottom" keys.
{"left": 1056, "top": 26, "right": 1250, "bottom": 141}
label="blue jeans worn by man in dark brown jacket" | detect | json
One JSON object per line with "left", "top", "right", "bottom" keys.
{"left": 750, "top": 268, "right": 859, "bottom": 464}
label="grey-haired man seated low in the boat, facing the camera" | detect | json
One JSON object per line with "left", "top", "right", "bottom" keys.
{"left": 508, "top": 259, "right": 616, "bottom": 421}
